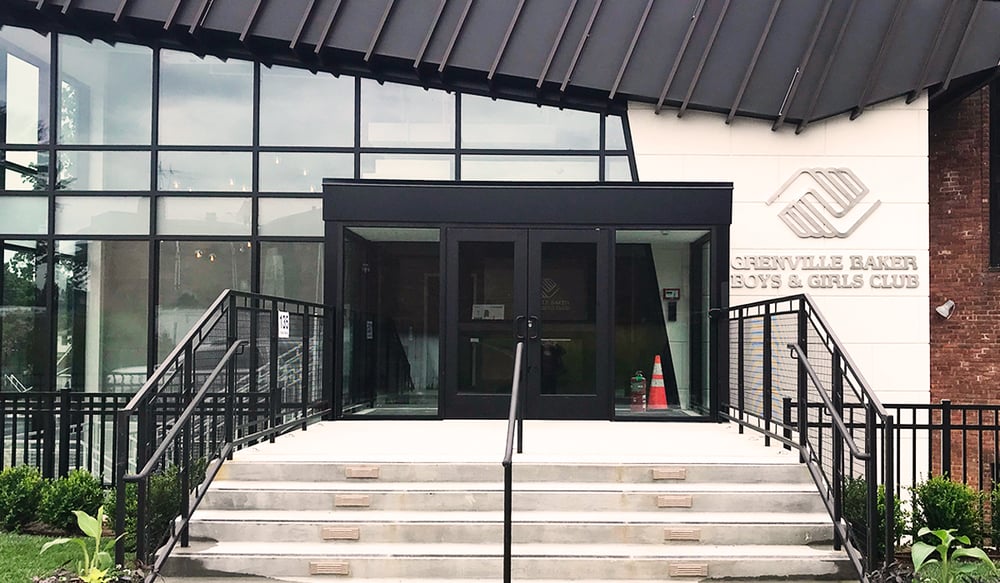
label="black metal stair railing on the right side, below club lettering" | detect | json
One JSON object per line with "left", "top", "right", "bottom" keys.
{"left": 721, "top": 295, "right": 897, "bottom": 580}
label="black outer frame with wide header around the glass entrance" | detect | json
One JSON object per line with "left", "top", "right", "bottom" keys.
{"left": 323, "top": 179, "right": 733, "bottom": 420}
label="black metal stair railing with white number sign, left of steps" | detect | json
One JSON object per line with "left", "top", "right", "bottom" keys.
{"left": 115, "top": 290, "right": 331, "bottom": 581}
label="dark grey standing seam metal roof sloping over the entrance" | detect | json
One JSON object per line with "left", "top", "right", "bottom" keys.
{"left": 0, "top": 0, "right": 1000, "bottom": 131}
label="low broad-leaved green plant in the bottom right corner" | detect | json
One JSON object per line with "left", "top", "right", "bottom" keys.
{"left": 910, "top": 526, "right": 997, "bottom": 583}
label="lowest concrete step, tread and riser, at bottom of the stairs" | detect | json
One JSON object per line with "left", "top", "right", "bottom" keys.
{"left": 164, "top": 543, "right": 851, "bottom": 580}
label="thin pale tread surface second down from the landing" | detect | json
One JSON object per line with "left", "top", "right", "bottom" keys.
{"left": 184, "top": 509, "right": 830, "bottom": 528}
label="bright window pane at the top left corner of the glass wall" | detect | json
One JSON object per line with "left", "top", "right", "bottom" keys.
{"left": 0, "top": 26, "right": 50, "bottom": 144}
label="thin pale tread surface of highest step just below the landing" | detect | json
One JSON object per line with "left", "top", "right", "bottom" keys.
{"left": 209, "top": 480, "right": 816, "bottom": 494}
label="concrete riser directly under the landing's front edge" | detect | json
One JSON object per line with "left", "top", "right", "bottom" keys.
{"left": 217, "top": 460, "right": 812, "bottom": 484}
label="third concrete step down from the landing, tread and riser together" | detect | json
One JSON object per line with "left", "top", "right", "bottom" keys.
{"left": 190, "top": 510, "right": 833, "bottom": 550}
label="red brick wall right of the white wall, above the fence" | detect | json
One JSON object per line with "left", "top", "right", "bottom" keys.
{"left": 928, "top": 89, "right": 1000, "bottom": 403}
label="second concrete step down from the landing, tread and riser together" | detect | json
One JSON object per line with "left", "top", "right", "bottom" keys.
{"left": 201, "top": 482, "right": 824, "bottom": 513}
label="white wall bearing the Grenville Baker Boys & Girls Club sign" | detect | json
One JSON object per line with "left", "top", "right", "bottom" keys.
{"left": 629, "top": 97, "right": 931, "bottom": 402}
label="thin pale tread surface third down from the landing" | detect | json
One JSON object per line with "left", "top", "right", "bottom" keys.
{"left": 172, "top": 541, "right": 845, "bottom": 560}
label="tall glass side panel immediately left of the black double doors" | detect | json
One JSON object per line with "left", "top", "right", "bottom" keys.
{"left": 340, "top": 228, "right": 441, "bottom": 415}
